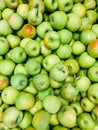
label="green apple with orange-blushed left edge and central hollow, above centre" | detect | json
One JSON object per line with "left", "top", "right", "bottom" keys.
{"left": 44, "top": 31, "right": 60, "bottom": 50}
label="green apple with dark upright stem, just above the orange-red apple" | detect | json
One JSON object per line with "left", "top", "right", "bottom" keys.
{"left": 27, "top": 8, "right": 43, "bottom": 26}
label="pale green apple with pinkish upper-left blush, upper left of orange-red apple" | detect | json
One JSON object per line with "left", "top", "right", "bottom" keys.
{"left": 7, "top": 13, "right": 24, "bottom": 30}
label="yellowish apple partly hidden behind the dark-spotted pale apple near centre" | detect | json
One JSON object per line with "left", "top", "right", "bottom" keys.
{"left": 64, "top": 59, "right": 80, "bottom": 75}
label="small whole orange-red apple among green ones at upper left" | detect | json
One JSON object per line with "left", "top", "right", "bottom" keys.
{"left": 22, "top": 24, "right": 36, "bottom": 38}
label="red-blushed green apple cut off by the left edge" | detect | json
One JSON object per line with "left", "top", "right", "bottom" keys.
{"left": 0, "top": 74, "right": 9, "bottom": 90}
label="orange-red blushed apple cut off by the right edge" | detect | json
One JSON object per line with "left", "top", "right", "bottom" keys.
{"left": 87, "top": 39, "right": 98, "bottom": 58}
